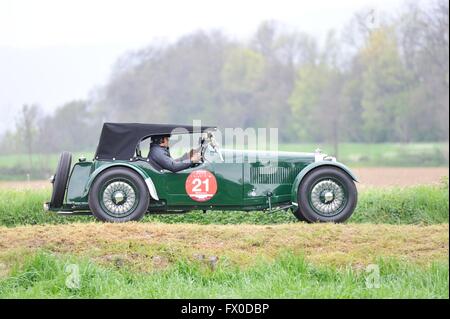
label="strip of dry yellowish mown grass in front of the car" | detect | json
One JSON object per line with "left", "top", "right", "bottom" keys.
{"left": 0, "top": 223, "right": 449, "bottom": 269}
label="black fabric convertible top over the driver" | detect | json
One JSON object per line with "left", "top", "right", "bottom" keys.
{"left": 95, "top": 123, "right": 216, "bottom": 160}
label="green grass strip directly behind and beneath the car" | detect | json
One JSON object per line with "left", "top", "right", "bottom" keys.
{"left": 0, "top": 181, "right": 449, "bottom": 226}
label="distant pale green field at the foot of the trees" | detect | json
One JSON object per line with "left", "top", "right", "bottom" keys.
{"left": 0, "top": 143, "right": 449, "bottom": 180}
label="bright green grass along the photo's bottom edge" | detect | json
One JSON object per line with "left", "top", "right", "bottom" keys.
{"left": 0, "top": 252, "right": 449, "bottom": 298}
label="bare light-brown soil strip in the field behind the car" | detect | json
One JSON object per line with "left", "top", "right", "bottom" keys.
{"left": 0, "top": 167, "right": 449, "bottom": 189}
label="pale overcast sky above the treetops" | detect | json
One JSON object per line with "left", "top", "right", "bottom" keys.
{"left": 0, "top": 0, "right": 418, "bottom": 133}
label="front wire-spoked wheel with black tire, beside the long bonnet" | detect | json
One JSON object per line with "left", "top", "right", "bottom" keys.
{"left": 294, "top": 166, "right": 358, "bottom": 223}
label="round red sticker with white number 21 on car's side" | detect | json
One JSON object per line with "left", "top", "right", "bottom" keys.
{"left": 185, "top": 170, "right": 217, "bottom": 202}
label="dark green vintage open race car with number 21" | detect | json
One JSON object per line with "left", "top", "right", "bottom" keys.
{"left": 44, "top": 123, "right": 357, "bottom": 222}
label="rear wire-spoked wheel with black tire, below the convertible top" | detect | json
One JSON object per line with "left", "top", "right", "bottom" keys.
{"left": 89, "top": 167, "right": 150, "bottom": 223}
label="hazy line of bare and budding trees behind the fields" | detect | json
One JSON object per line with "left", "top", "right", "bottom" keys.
{"left": 0, "top": 0, "right": 449, "bottom": 153}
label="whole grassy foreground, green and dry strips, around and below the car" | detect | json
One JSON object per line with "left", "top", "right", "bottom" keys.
{"left": 0, "top": 179, "right": 449, "bottom": 298}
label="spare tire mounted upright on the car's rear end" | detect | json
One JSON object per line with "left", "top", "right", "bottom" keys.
{"left": 50, "top": 152, "right": 72, "bottom": 208}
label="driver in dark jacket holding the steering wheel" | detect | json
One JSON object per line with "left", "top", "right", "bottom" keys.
{"left": 148, "top": 135, "right": 200, "bottom": 173}
